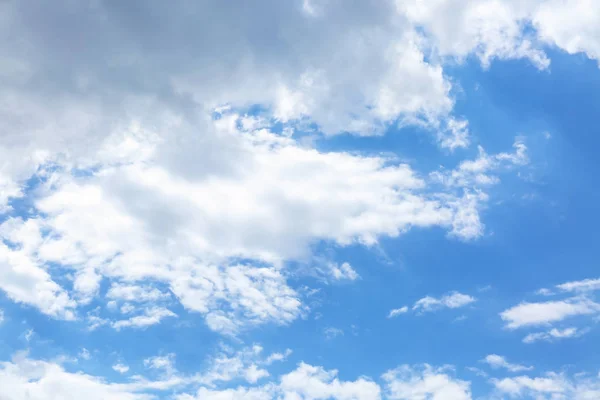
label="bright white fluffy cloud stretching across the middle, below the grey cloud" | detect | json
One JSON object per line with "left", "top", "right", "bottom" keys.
{"left": 2, "top": 114, "right": 520, "bottom": 334}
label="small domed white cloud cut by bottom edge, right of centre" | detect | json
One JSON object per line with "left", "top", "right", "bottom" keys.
{"left": 383, "top": 365, "right": 472, "bottom": 400}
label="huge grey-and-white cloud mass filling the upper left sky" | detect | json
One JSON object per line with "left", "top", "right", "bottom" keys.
{"left": 0, "top": 1, "right": 543, "bottom": 335}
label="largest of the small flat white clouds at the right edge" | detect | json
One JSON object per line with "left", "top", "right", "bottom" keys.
{"left": 500, "top": 297, "right": 600, "bottom": 329}
